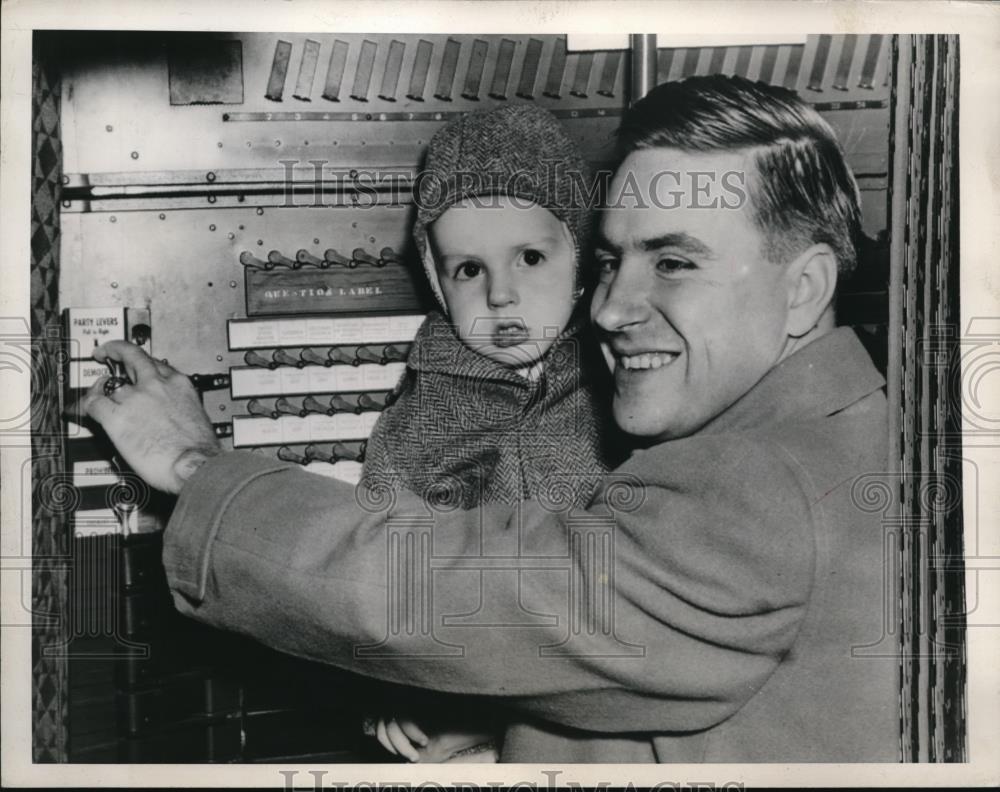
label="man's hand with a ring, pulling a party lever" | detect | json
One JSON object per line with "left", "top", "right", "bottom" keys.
{"left": 79, "top": 341, "right": 222, "bottom": 494}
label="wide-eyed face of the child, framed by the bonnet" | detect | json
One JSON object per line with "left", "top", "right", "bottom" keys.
{"left": 429, "top": 196, "right": 576, "bottom": 368}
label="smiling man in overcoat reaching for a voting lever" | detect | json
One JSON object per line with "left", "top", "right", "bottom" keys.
{"left": 86, "top": 77, "right": 899, "bottom": 763}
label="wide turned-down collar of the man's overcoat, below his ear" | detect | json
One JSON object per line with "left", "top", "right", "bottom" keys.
{"left": 699, "top": 327, "right": 885, "bottom": 434}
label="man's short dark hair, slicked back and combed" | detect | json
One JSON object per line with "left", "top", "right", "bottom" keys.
{"left": 618, "top": 75, "right": 861, "bottom": 277}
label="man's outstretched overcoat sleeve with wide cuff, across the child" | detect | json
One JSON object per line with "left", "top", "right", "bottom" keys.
{"left": 164, "top": 437, "right": 814, "bottom": 732}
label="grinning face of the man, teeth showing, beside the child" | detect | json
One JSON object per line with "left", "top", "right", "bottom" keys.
{"left": 591, "top": 148, "right": 789, "bottom": 440}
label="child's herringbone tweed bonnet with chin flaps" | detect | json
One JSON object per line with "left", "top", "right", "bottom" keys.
{"left": 413, "top": 104, "right": 591, "bottom": 311}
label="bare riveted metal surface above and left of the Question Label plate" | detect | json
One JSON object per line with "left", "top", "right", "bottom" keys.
{"left": 61, "top": 201, "right": 424, "bottom": 442}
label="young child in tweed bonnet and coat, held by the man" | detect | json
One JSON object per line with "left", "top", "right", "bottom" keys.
{"left": 361, "top": 105, "right": 613, "bottom": 761}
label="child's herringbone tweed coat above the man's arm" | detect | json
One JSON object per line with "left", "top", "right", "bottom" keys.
{"left": 362, "top": 311, "right": 614, "bottom": 509}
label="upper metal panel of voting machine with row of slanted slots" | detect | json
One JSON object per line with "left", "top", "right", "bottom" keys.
{"left": 61, "top": 33, "right": 626, "bottom": 183}
